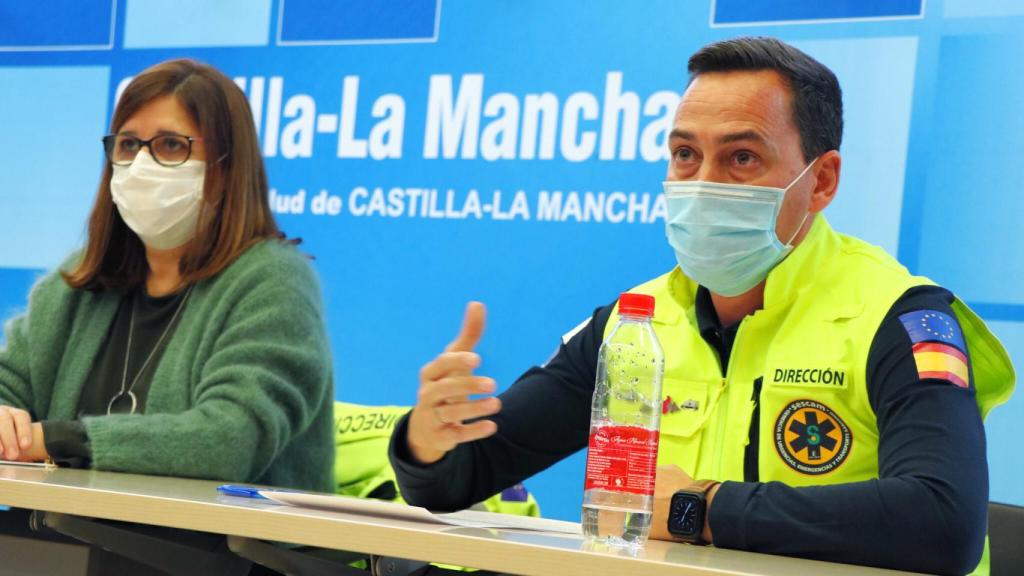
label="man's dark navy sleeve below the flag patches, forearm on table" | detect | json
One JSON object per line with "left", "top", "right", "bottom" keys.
{"left": 710, "top": 287, "right": 988, "bottom": 574}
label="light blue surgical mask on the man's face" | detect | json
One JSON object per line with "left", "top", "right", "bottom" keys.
{"left": 664, "top": 162, "right": 814, "bottom": 296}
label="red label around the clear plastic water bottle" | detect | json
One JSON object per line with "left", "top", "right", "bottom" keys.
{"left": 585, "top": 426, "right": 658, "bottom": 496}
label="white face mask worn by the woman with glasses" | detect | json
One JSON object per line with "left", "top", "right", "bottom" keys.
{"left": 111, "top": 151, "right": 206, "bottom": 250}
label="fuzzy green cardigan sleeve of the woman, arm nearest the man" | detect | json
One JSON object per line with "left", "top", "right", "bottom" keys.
{"left": 83, "top": 241, "right": 334, "bottom": 482}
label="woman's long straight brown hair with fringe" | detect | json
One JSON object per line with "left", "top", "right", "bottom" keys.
{"left": 63, "top": 59, "right": 284, "bottom": 291}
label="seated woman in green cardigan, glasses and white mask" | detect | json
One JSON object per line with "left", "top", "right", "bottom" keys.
{"left": 0, "top": 60, "right": 334, "bottom": 491}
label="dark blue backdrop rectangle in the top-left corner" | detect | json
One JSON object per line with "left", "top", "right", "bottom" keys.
{"left": 0, "top": 0, "right": 116, "bottom": 50}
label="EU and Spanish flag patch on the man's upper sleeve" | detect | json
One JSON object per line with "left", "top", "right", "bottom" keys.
{"left": 899, "top": 310, "right": 971, "bottom": 388}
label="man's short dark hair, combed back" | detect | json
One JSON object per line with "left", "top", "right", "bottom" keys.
{"left": 689, "top": 37, "right": 843, "bottom": 162}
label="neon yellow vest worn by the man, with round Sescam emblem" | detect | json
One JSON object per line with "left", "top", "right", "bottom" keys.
{"left": 605, "top": 214, "right": 1015, "bottom": 574}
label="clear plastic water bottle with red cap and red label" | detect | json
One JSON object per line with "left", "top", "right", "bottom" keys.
{"left": 583, "top": 293, "right": 665, "bottom": 546}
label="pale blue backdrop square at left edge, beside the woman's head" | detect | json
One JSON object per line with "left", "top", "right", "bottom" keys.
{"left": 0, "top": 66, "right": 111, "bottom": 268}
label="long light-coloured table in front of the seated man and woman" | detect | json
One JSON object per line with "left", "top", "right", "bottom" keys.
{"left": 0, "top": 465, "right": 917, "bottom": 576}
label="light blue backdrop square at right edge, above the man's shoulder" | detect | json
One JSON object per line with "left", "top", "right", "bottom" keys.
{"left": 920, "top": 35, "right": 1024, "bottom": 307}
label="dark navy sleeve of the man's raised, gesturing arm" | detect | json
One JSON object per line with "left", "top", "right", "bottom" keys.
{"left": 389, "top": 304, "right": 612, "bottom": 510}
